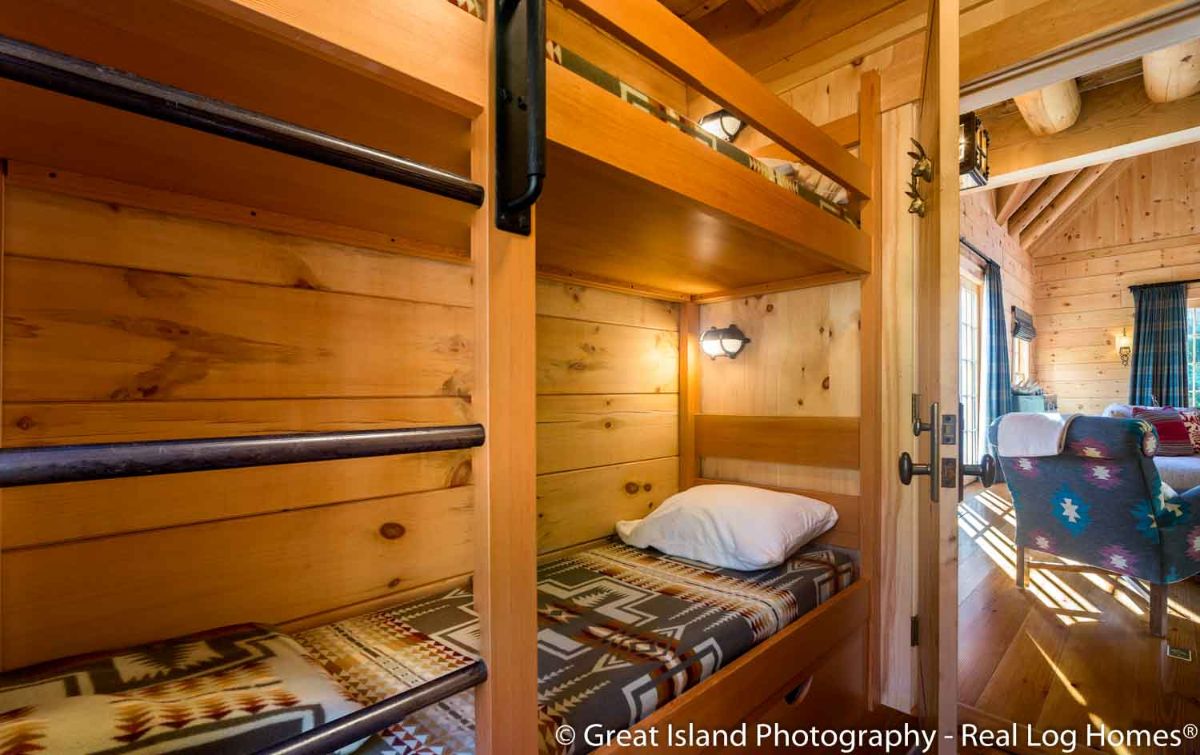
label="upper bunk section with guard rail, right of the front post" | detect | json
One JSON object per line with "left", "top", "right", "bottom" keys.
{"left": 538, "top": 0, "right": 870, "bottom": 298}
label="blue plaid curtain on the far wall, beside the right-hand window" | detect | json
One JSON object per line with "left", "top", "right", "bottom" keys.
{"left": 1129, "top": 283, "right": 1188, "bottom": 407}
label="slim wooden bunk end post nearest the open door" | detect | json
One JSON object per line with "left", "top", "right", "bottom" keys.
{"left": 858, "top": 71, "right": 884, "bottom": 708}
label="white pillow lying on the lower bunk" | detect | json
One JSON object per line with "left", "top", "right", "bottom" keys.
{"left": 617, "top": 485, "right": 838, "bottom": 571}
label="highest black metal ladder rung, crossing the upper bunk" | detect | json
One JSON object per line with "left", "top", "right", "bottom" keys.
{"left": 0, "top": 36, "right": 484, "bottom": 206}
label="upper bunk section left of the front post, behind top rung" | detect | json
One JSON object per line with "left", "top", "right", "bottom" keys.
{"left": 0, "top": 0, "right": 487, "bottom": 260}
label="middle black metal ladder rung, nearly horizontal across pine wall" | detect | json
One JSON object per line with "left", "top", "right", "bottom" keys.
{"left": 0, "top": 425, "right": 485, "bottom": 487}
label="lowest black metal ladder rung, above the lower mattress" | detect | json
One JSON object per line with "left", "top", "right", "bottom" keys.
{"left": 256, "top": 660, "right": 487, "bottom": 755}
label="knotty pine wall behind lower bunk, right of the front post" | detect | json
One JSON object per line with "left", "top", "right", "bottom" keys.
{"left": 538, "top": 280, "right": 679, "bottom": 553}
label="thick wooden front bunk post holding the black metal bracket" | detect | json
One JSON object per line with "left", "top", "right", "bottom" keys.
{"left": 470, "top": 19, "right": 538, "bottom": 755}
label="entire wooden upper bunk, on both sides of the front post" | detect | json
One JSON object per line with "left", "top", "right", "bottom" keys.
{"left": 0, "top": 0, "right": 871, "bottom": 299}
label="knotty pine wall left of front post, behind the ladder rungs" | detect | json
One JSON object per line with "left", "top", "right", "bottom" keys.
{"left": 0, "top": 174, "right": 473, "bottom": 667}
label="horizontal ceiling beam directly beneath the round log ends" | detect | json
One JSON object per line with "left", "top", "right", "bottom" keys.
{"left": 980, "top": 72, "right": 1200, "bottom": 187}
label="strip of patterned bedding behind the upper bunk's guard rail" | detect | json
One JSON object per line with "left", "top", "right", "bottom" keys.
{"left": 546, "top": 41, "right": 858, "bottom": 227}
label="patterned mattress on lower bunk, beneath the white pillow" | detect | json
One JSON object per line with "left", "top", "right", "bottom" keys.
{"left": 296, "top": 541, "right": 856, "bottom": 755}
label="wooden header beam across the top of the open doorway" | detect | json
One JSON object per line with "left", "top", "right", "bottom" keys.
{"left": 959, "top": 0, "right": 1200, "bottom": 113}
